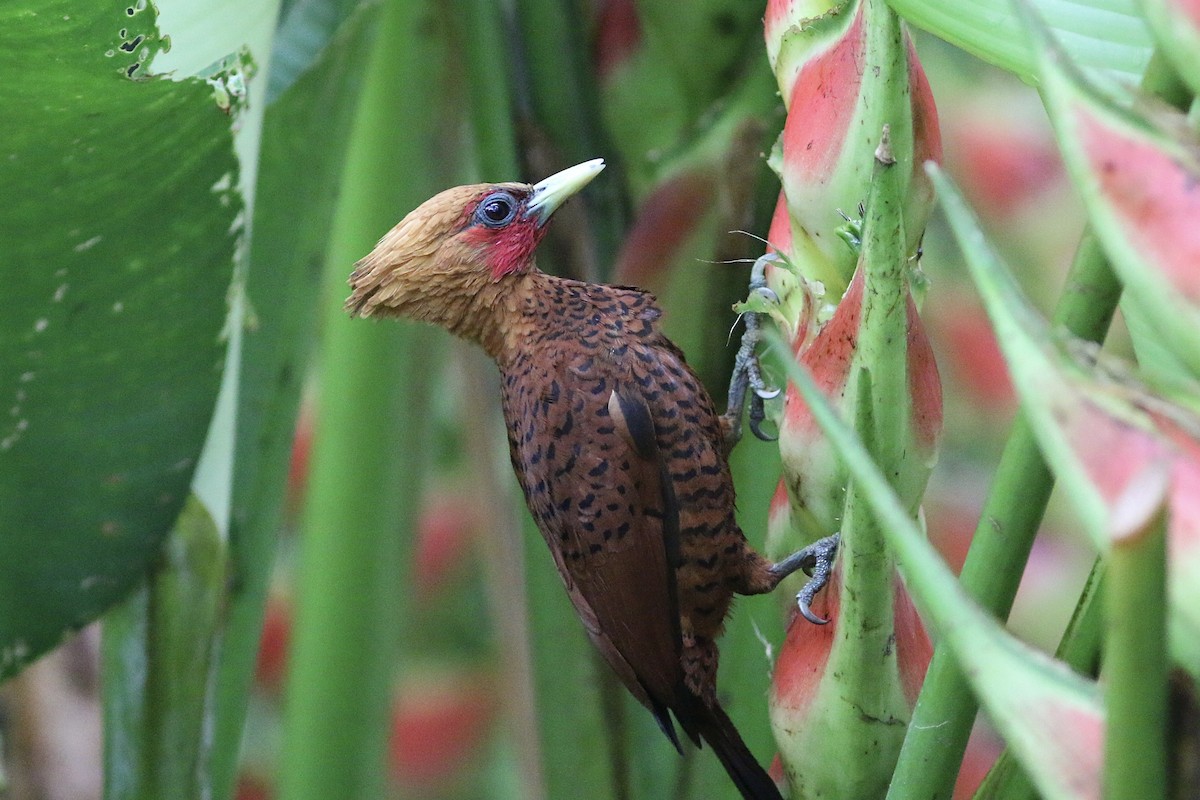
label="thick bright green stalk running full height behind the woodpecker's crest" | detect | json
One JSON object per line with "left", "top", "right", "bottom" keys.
{"left": 280, "top": 0, "right": 439, "bottom": 800}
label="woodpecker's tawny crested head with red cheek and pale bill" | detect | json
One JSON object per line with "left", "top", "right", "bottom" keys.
{"left": 346, "top": 158, "right": 605, "bottom": 321}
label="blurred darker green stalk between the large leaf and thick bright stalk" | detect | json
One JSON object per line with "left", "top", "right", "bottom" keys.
{"left": 212, "top": 6, "right": 378, "bottom": 800}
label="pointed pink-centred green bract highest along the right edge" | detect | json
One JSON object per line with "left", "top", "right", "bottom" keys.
{"left": 1031, "top": 6, "right": 1200, "bottom": 384}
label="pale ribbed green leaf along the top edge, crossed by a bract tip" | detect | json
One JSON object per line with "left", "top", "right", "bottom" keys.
{"left": 888, "top": 0, "right": 1152, "bottom": 83}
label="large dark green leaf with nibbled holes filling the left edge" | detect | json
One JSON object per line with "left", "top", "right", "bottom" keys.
{"left": 0, "top": 0, "right": 242, "bottom": 676}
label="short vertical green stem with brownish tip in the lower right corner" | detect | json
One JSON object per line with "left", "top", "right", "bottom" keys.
{"left": 1104, "top": 509, "right": 1168, "bottom": 800}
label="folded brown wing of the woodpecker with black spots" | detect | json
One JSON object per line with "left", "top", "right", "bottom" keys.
{"left": 505, "top": 350, "right": 683, "bottom": 747}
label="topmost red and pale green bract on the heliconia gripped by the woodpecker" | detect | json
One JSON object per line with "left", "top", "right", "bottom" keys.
{"left": 766, "top": 2, "right": 942, "bottom": 295}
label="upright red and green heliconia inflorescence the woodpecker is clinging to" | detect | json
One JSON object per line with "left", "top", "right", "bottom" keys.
{"left": 764, "top": 0, "right": 942, "bottom": 798}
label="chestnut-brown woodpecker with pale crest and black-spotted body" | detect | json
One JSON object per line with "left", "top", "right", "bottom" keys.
{"left": 347, "top": 161, "right": 835, "bottom": 799}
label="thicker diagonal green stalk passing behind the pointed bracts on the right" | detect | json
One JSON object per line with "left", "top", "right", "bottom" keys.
{"left": 888, "top": 54, "right": 1187, "bottom": 800}
